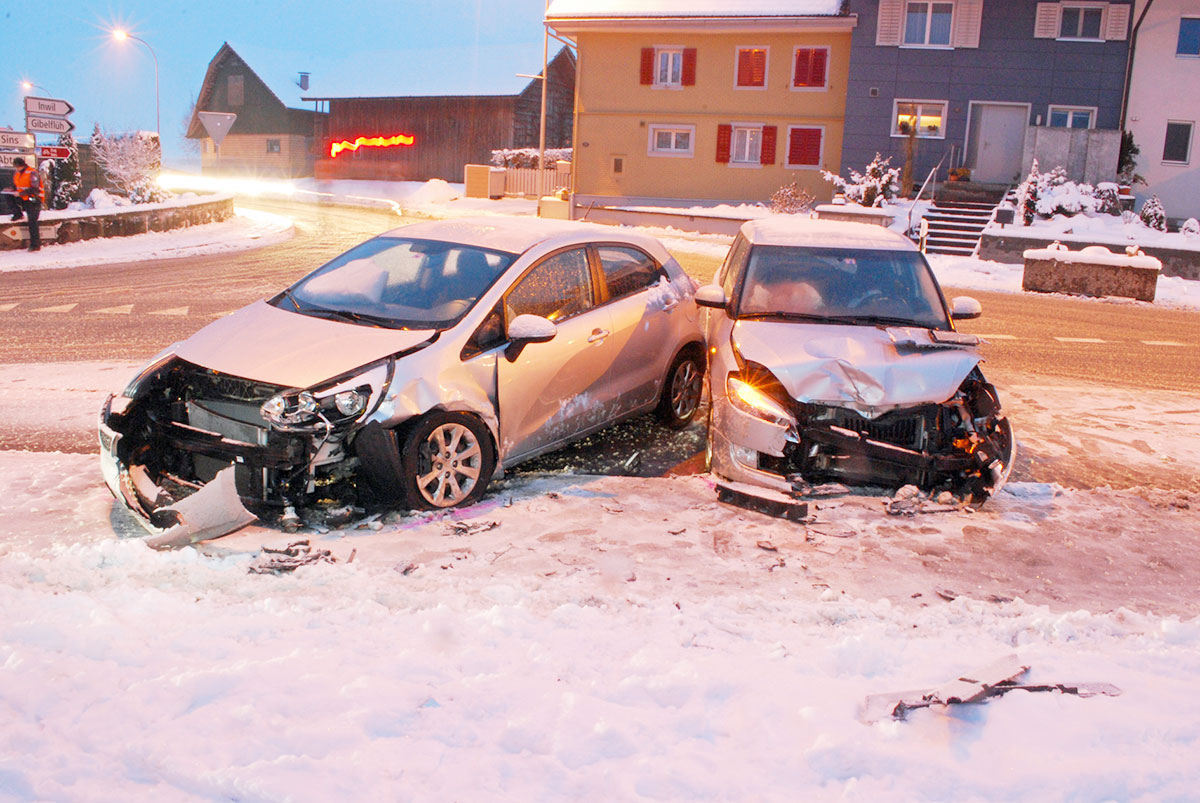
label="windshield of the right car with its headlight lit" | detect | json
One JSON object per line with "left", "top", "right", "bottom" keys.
{"left": 737, "top": 245, "right": 950, "bottom": 329}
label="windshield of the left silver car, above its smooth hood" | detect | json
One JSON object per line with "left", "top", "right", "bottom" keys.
{"left": 271, "top": 236, "right": 516, "bottom": 329}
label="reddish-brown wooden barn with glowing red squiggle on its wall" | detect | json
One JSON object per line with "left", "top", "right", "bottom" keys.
{"left": 304, "top": 48, "right": 575, "bottom": 181}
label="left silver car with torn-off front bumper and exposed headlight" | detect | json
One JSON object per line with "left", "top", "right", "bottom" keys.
{"left": 100, "top": 218, "right": 704, "bottom": 544}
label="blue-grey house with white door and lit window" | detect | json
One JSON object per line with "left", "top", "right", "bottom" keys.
{"left": 841, "top": 0, "right": 1133, "bottom": 185}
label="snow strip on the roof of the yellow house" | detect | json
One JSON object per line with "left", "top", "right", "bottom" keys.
{"left": 546, "top": 0, "right": 842, "bottom": 19}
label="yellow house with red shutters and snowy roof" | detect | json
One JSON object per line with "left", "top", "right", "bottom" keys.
{"left": 546, "top": 0, "right": 856, "bottom": 217}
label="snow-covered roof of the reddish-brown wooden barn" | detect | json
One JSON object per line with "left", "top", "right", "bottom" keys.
{"left": 229, "top": 42, "right": 541, "bottom": 109}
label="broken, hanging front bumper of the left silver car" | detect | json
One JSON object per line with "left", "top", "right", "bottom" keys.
{"left": 97, "top": 395, "right": 257, "bottom": 549}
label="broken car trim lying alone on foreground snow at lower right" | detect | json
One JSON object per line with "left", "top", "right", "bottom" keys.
{"left": 862, "top": 654, "right": 1121, "bottom": 724}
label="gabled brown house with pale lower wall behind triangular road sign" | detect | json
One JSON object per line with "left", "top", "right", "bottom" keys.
{"left": 187, "top": 42, "right": 325, "bottom": 176}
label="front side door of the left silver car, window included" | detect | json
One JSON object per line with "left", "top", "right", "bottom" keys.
{"left": 497, "top": 246, "right": 616, "bottom": 463}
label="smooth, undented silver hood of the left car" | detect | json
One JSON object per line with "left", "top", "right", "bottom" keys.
{"left": 175, "top": 301, "right": 436, "bottom": 388}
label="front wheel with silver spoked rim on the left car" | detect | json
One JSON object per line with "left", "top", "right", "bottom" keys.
{"left": 401, "top": 412, "right": 496, "bottom": 510}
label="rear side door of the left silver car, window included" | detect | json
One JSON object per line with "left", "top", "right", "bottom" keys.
{"left": 594, "top": 244, "right": 684, "bottom": 413}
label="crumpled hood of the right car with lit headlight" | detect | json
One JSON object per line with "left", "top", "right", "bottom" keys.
{"left": 733, "top": 320, "right": 980, "bottom": 415}
